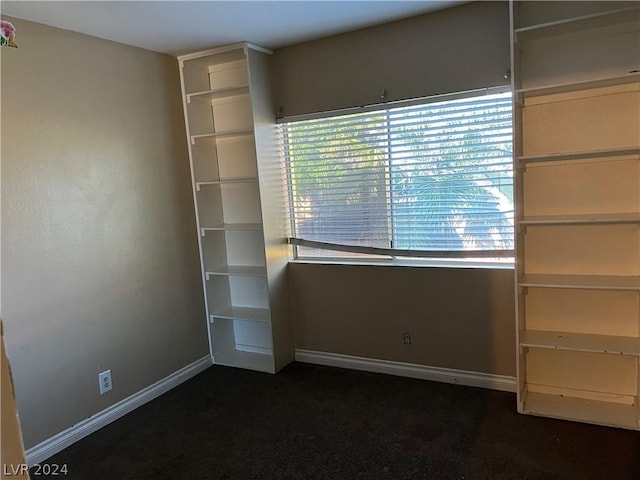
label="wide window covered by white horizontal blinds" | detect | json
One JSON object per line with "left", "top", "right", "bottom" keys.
{"left": 280, "top": 91, "right": 514, "bottom": 259}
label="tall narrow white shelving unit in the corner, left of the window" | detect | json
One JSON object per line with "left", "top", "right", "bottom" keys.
{"left": 179, "top": 43, "right": 293, "bottom": 373}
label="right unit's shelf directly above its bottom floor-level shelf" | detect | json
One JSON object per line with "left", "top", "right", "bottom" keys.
{"left": 520, "top": 330, "right": 640, "bottom": 356}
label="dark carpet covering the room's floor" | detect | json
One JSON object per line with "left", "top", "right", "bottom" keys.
{"left": 34, "top": 363, "right": 640, "bottom": 480}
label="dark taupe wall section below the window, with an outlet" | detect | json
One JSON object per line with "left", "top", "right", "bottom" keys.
{"left": 289, "top": 263, "right": 516, "bottom": 376}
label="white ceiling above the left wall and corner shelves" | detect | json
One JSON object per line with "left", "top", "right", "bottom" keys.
{"left": 0, "top": 0, "right": 464, "bottom": 55}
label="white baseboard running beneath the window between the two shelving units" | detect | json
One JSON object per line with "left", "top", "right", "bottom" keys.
{"left": 296, "top": 349, "right": 516, "bottom": 393}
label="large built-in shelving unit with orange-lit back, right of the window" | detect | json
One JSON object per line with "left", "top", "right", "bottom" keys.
{"left": 511, "top": 1, "right": 640, "bottom": 430}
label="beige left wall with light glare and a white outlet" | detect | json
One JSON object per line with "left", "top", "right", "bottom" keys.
{"left": 2, "top": 19, "right": 208, "bottom": 448}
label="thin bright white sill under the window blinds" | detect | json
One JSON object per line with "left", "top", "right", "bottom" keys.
{"left": 289, "top": 257, "right": 515, "bottom": 270}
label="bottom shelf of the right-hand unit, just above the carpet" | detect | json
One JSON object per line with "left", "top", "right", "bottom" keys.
{"left": 523, "top": 392, "right": 640, "bottom": 429}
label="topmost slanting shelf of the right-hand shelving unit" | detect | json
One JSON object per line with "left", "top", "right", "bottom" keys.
{"left": 513, "top": 6, "right": 640, "bottom": 42}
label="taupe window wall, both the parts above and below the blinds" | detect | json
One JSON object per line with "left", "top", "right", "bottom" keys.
{"left": 273, "top": 2, "right": 516, "bottom": 375}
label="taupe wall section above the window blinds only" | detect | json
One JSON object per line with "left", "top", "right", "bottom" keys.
{"left": 273, "top": 1, "right": 510, "bottom": 116}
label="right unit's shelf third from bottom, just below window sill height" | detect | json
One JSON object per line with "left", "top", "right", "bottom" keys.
{"left": 518, "top": 274, "right": 640, "bottom": 290}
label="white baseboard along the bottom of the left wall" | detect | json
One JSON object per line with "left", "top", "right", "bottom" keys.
{"left": 26, "top": 355, "right": 212, "bottom": 467}
